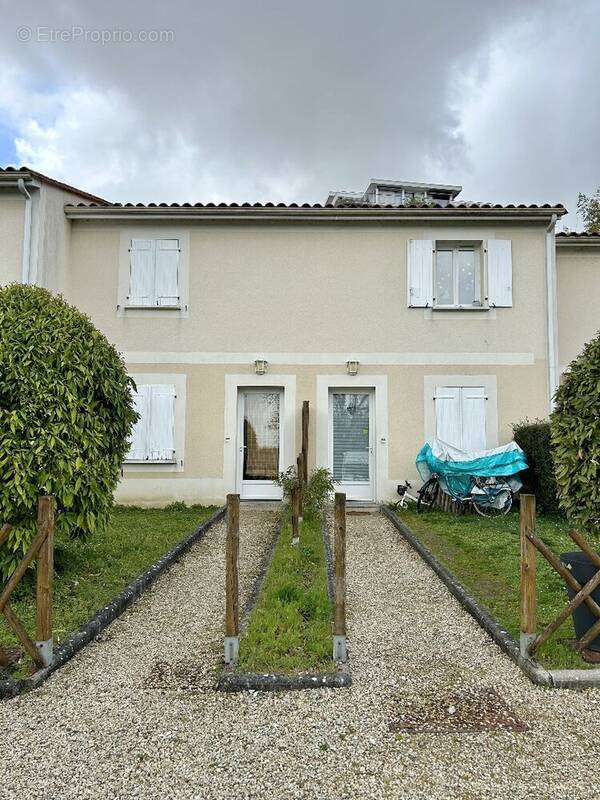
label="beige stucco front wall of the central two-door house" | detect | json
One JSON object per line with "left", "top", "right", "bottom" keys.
{"left": 65, "top": 220, "right": 548, "bottom": 505}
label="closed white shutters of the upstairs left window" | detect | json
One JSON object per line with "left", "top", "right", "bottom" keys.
{"left": 127, "top": 239, "right": 180, "bottom": 308}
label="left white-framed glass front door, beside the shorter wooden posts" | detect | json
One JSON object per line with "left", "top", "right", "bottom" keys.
{"left": 237, "top": 387, "right": 283, "bottom": 500}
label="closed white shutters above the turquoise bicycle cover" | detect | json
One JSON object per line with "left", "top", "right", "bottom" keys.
{"left": 434, "top": 386, "right": 487, "bottom": 450}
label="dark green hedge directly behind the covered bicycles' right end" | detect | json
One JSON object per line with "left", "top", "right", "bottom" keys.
{"left": 513, "top": 419, "right": 560, "bottom": 514}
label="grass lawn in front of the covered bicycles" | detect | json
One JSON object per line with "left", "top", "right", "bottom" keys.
{"left": 398, "top": 510, "right": 589, "bottom": 669}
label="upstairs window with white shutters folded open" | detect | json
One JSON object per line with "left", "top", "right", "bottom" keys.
{"left": 408, "top": 239, "right": 513, "bottom": 310}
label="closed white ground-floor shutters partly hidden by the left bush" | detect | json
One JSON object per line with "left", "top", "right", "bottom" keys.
{"left": 126, "top": 384, "right": 176, "bottom": 464}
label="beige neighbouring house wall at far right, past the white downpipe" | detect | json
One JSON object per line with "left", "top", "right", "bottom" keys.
{"left": 556, "top": 239, "right": 600, "bottom": 373}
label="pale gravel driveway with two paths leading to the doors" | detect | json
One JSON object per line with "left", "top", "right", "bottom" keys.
{"left": 0, "top": 510, "right": 600, "bottom": 800}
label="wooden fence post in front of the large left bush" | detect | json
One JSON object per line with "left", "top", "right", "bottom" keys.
{"left": 35, "top": 495, "right": 54, "bottom": 666}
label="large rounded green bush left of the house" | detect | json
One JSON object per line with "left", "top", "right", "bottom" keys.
{"left": 0, "top": 284, "right": 137, "bottom": 576}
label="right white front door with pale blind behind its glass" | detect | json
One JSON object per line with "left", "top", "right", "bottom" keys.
{"left": 329, "top": 389, "right": 375, "bottom": 500}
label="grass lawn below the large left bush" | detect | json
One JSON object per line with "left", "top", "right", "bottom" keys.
{"left": 0, "top": 506, "right": 215, "bottom": 674}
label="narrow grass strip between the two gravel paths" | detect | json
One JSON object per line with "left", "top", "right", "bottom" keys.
{"left": 237, "top": 517, "right": 336, "bottom": 674}
